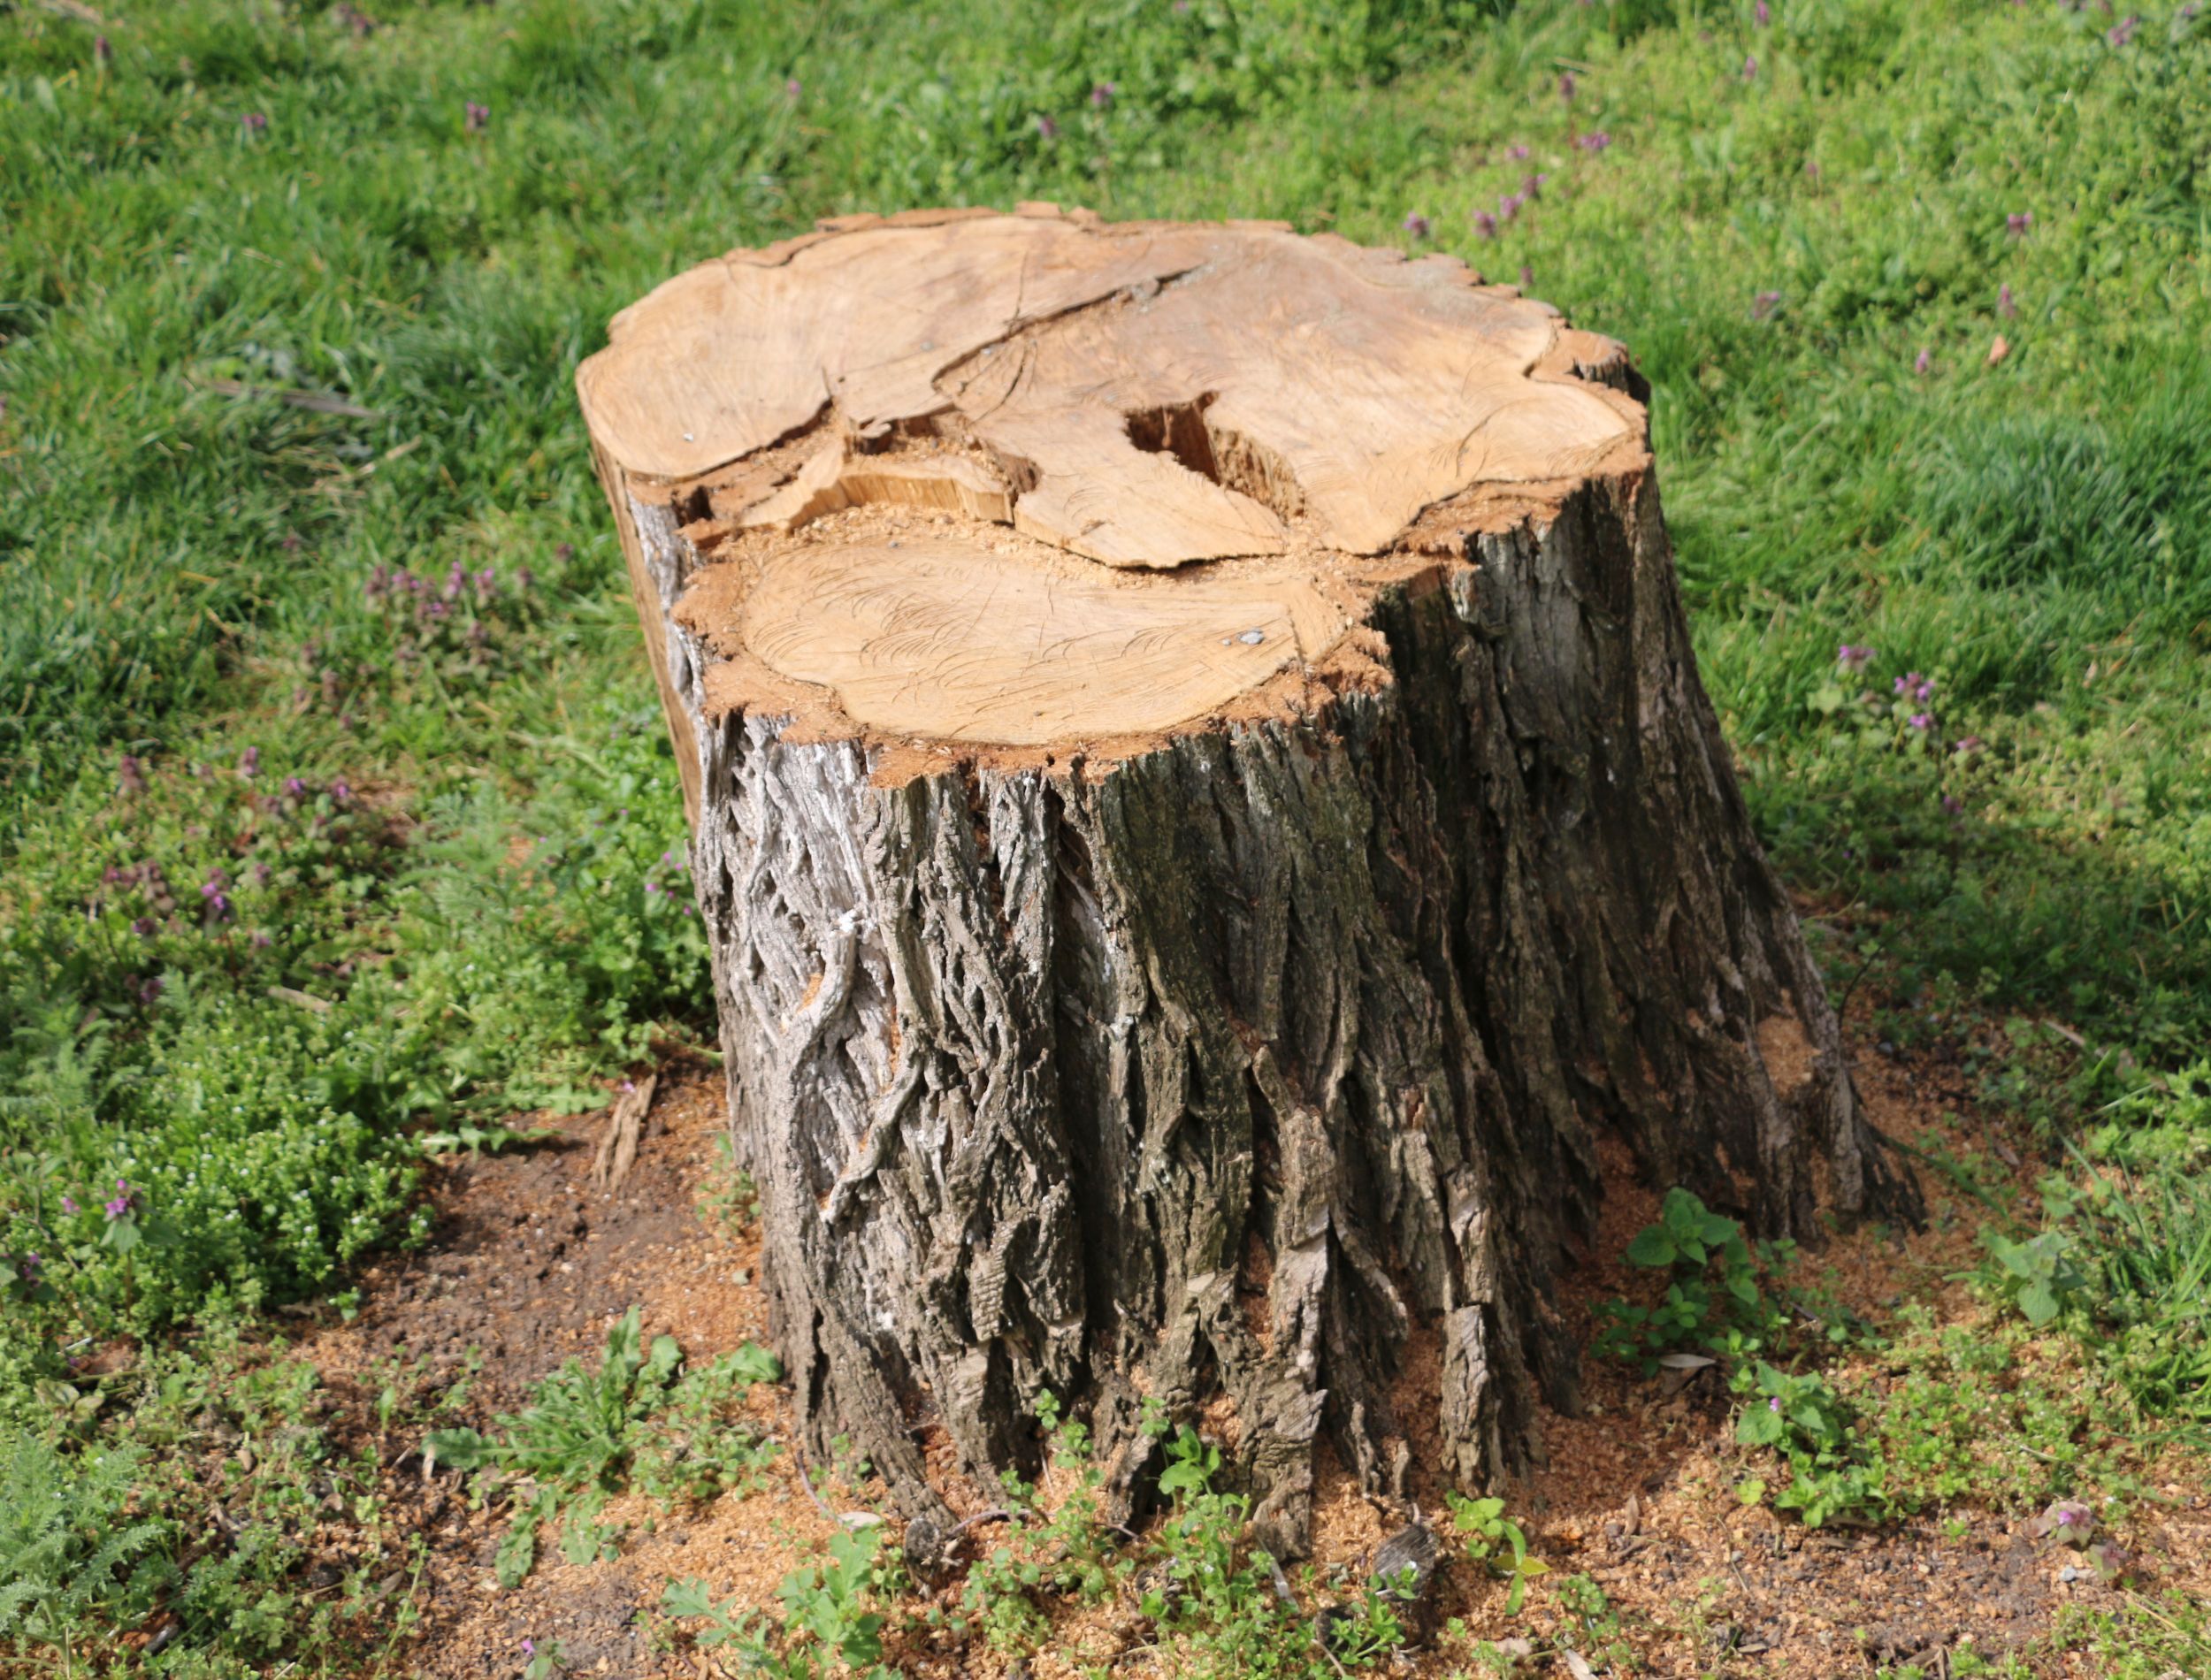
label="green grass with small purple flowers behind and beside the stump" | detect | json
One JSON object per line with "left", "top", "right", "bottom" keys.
{"left": 0, "top": 0, "right": 2211, "bottom": 1674}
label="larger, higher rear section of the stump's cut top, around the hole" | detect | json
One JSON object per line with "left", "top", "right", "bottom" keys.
{"left": 578, "top": 215, "right": 1641, "bottom": 566}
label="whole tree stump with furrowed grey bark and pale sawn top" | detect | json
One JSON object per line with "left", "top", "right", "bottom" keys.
{"left": 578, "top": 206, "right": 1915, "bottom": 1550}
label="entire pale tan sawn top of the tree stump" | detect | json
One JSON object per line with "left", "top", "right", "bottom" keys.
{"left": 578, "top": 206, "right": 1648, "bottom": 774}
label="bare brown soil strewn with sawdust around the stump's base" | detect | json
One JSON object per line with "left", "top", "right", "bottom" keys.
{"left": 289, "top": 1052, "right": 2211, "bottom": 1680}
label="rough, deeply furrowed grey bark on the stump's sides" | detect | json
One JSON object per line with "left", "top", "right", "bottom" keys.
{"left": 593, "top": 455, "right": 1915, "bottom": 1552}
